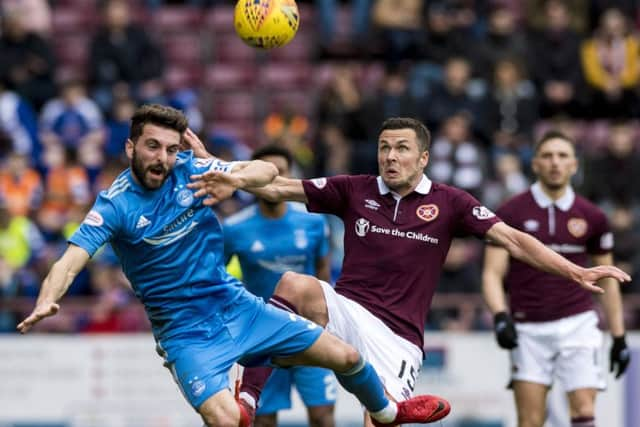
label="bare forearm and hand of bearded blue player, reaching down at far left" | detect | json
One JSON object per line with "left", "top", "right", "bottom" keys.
{"left": 17, "top": 244, "right": 89, "bottom": 334}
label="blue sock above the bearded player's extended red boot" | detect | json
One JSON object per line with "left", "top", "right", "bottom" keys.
{"left": 335, "top": 356, "right": 389, "bottom": 412}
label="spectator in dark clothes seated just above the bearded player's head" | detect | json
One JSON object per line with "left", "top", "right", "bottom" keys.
{"left": 89, "top": 0, "right": 164, "bottom": 112}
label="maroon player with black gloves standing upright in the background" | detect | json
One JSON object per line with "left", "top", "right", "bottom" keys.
{"left": 483, "top": 132, "right": 629, "bottom": 427}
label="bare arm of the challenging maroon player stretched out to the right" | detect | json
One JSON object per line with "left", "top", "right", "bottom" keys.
{"left": 487, "top": 222, "right": 631, "bottom": 293}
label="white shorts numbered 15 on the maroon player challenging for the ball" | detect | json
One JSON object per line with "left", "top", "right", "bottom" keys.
{"left": 320, "top": 280, "right": 422, "bottom": 401}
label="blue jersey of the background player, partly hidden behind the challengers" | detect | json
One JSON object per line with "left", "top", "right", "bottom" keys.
{"left": 224, "top": 203, "right": 329, "bottom": 300}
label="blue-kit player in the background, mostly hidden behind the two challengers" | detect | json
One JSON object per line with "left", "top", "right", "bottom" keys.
{"left": 223, "top": 145, "right": 337, "bottom": 427}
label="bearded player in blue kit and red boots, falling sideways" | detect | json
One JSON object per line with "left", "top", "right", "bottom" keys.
{"left": 17, "top": 105, "right": 450, "bottom": 427}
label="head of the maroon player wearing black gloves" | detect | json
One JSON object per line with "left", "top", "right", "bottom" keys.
{"left": 532, "top": 138, "right": 578, "bottom": 190}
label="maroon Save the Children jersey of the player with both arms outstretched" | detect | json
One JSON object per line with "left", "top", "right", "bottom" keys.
{"left": 303, "top": 175, "right": 499, "bottom": 348}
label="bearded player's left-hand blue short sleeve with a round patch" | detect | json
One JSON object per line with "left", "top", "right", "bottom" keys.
{"left": 69, "top": 192, "right": 120, "bottom": 256}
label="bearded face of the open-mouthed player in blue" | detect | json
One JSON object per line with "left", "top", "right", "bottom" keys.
{"left": 126, "top": 124, "right": 180, "bottom": 190}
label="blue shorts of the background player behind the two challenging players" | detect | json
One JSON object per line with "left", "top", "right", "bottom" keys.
{"left": 256, "top": 366, "right": 338, "bottom": 415}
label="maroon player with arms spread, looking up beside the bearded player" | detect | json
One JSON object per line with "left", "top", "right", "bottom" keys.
{"left": 190, "top": 118, "right": 630, "bottom": 427}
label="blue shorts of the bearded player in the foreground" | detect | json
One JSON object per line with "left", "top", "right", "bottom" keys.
{"left": 158, "top": 291, "right": 323, "bottom": 409}
